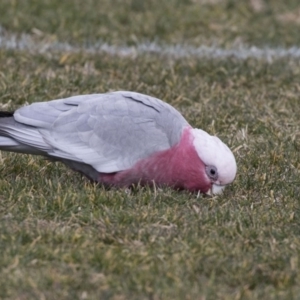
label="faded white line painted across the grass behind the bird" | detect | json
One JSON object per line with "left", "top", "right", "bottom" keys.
{"left": 0, "top": 27, "right": 300, "bottom": 62}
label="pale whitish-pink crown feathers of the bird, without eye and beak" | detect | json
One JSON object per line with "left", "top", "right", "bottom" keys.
{"left": 191, "top": 129, "right": 237, "bottom": 185}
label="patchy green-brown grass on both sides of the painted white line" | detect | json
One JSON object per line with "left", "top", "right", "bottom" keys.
{"left": 0, "top": 0, "right": 300, "bottom": 300}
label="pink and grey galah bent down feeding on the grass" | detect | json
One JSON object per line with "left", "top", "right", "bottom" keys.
{"left": 0, "top": 91, "right": 237, "bottom": 194}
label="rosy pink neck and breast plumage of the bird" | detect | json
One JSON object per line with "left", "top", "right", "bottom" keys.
{"left": 120, "top": 127, "right": 210, "bottom": 191}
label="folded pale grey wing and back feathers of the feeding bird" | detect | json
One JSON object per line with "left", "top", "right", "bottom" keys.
{"left": 14, "top": 92, "right": 188, "bottom": 173}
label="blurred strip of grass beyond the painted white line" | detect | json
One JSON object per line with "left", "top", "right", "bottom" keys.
{"left": 0, "top": 0, "right": 300, "bottom": 46}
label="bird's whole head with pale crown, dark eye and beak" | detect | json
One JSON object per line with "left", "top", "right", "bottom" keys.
{"left": 192, "top": 129, "right": 237, "bottom": 194}
